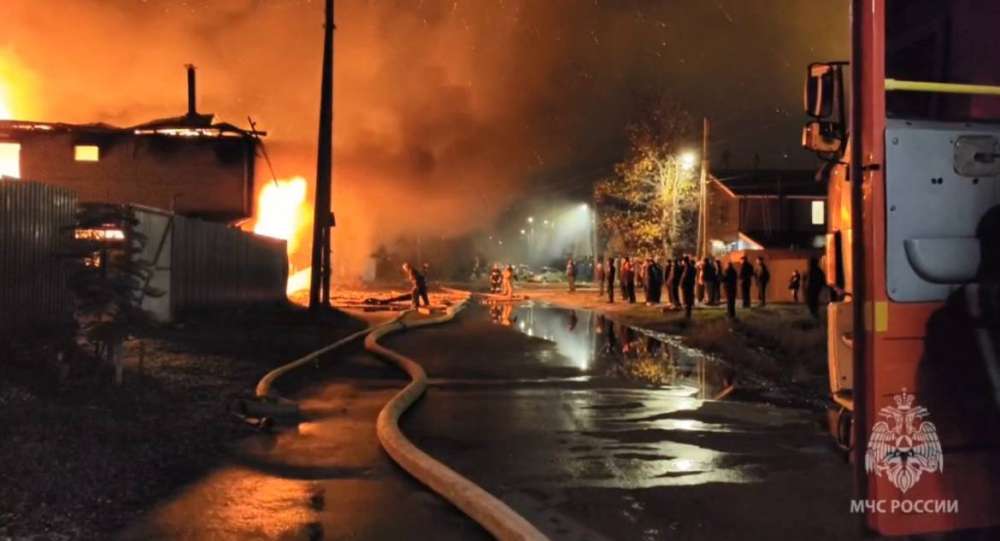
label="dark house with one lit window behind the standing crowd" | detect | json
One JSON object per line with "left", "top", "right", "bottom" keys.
{"left": 708, "top": 170, "right": 826, "bottom": 255}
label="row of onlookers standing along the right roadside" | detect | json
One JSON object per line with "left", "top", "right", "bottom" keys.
{"left": 584, "top": 255, "right": 827, "bottom": 318}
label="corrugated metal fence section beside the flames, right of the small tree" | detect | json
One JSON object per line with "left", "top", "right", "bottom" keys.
{"left": 170, "top": 216, "right": 288, "bottom": 315}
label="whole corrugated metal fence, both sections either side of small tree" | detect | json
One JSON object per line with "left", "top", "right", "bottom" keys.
{"left": 0, "top": 180, "right": 288, "bottom": 336}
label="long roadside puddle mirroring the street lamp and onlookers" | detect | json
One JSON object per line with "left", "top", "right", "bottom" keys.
{"left": 487, "top": 301, "right": 736, "bottom": 400}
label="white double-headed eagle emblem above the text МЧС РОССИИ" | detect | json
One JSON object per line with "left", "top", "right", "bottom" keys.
{"left": 865, "top": 389, "right": 944, "bottom": 493}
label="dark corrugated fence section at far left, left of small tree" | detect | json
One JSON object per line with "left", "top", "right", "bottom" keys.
{"left": 0, "top": 179, "right": 76, "bottom": 340}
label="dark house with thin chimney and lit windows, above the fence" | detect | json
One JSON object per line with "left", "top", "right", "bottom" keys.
{"left": 0, "top": 67, "right": 263, "bottom": 222}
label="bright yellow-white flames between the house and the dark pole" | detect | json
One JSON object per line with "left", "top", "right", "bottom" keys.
{"left": 253, "top": 177, "right": 309, "bottom": 295}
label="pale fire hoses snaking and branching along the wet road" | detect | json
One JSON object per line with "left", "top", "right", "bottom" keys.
{"left": 231, "top": 290, "right": 547, "bottom": 541}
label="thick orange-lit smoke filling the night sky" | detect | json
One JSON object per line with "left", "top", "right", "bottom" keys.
{"left": 0, "top": 0, "right": 847, "bottom": 278}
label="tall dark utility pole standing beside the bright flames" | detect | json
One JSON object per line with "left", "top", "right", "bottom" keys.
{"left": 309, "top": 0, "right": 335, "bottom": 311}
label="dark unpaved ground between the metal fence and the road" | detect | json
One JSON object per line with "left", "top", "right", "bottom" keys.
{"left": 0, "top": 307, "right": 363, "bottom": 540}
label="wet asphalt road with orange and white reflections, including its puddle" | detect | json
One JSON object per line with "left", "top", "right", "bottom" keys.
{"left": 115, "top": 303, "right": 858, "bottom": 540}
